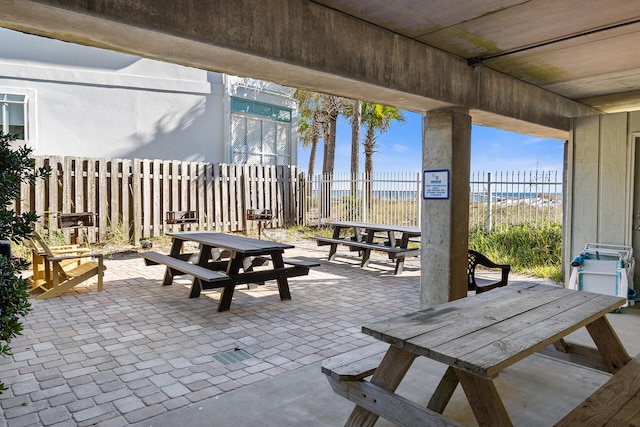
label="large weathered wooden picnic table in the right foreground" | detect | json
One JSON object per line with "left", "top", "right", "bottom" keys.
{"left": 322, "top": 283, "right": 631, "bottom": 426}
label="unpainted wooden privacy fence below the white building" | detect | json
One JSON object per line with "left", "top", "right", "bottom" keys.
{"left": 16, "top": 156, "right": 304, "bottom": 243}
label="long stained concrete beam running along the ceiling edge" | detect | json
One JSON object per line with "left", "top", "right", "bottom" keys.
{"left": 0, "top": 0, "right": 598, "bottom": 139}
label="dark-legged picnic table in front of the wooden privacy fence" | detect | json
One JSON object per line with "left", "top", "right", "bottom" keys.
{"left": 140, "top": 231, "right": 319, "bottom": 311}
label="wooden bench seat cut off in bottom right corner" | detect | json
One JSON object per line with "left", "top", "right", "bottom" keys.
{"left": 556, "top": 357, "right": 640, "bottom": 427}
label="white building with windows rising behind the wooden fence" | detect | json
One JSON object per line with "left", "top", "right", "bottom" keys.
{"left": 0, "top": 29, "right": 297, "bottom": 165}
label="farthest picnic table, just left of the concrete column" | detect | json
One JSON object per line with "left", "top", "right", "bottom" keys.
{"left": 313, "top": 221, "right": 422, "bottom": 274}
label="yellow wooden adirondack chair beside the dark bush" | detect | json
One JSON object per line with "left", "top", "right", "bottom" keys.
{"left": 32, "top": 232, "right": 106, "bottom": 299}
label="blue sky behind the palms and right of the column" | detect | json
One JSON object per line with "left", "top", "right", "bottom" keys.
{"left": 298, "top": 111, "right": 564, "bottom": 173}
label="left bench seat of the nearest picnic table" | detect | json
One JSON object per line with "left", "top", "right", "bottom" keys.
{"left": 322, "top": 342, "right": 461, "bottom": 427}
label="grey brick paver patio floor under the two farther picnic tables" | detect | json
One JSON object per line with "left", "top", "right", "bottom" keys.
{"left": 0, "top": 242, "right": 428, "bottom": 427}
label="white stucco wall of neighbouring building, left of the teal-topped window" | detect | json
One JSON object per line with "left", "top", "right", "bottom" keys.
{"left": 0, "top": 29, "right": 295, "bottom": 162}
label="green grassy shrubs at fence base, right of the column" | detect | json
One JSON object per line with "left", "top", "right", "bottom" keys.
{"left": 469, "top": 223, "right": 562, "bottom": 281}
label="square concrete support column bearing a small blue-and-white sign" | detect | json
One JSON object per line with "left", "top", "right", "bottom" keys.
{"left": 420, "top": 108, "right": 471, "bottom": 309}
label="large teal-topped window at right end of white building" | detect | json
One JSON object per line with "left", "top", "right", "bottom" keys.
{"left": 231, "top": 97, "right": 292, "bottom": 165}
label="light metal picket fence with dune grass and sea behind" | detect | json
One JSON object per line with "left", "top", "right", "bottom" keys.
{"left": 305, "top": 171, "right": 562, "bottom": 231}
